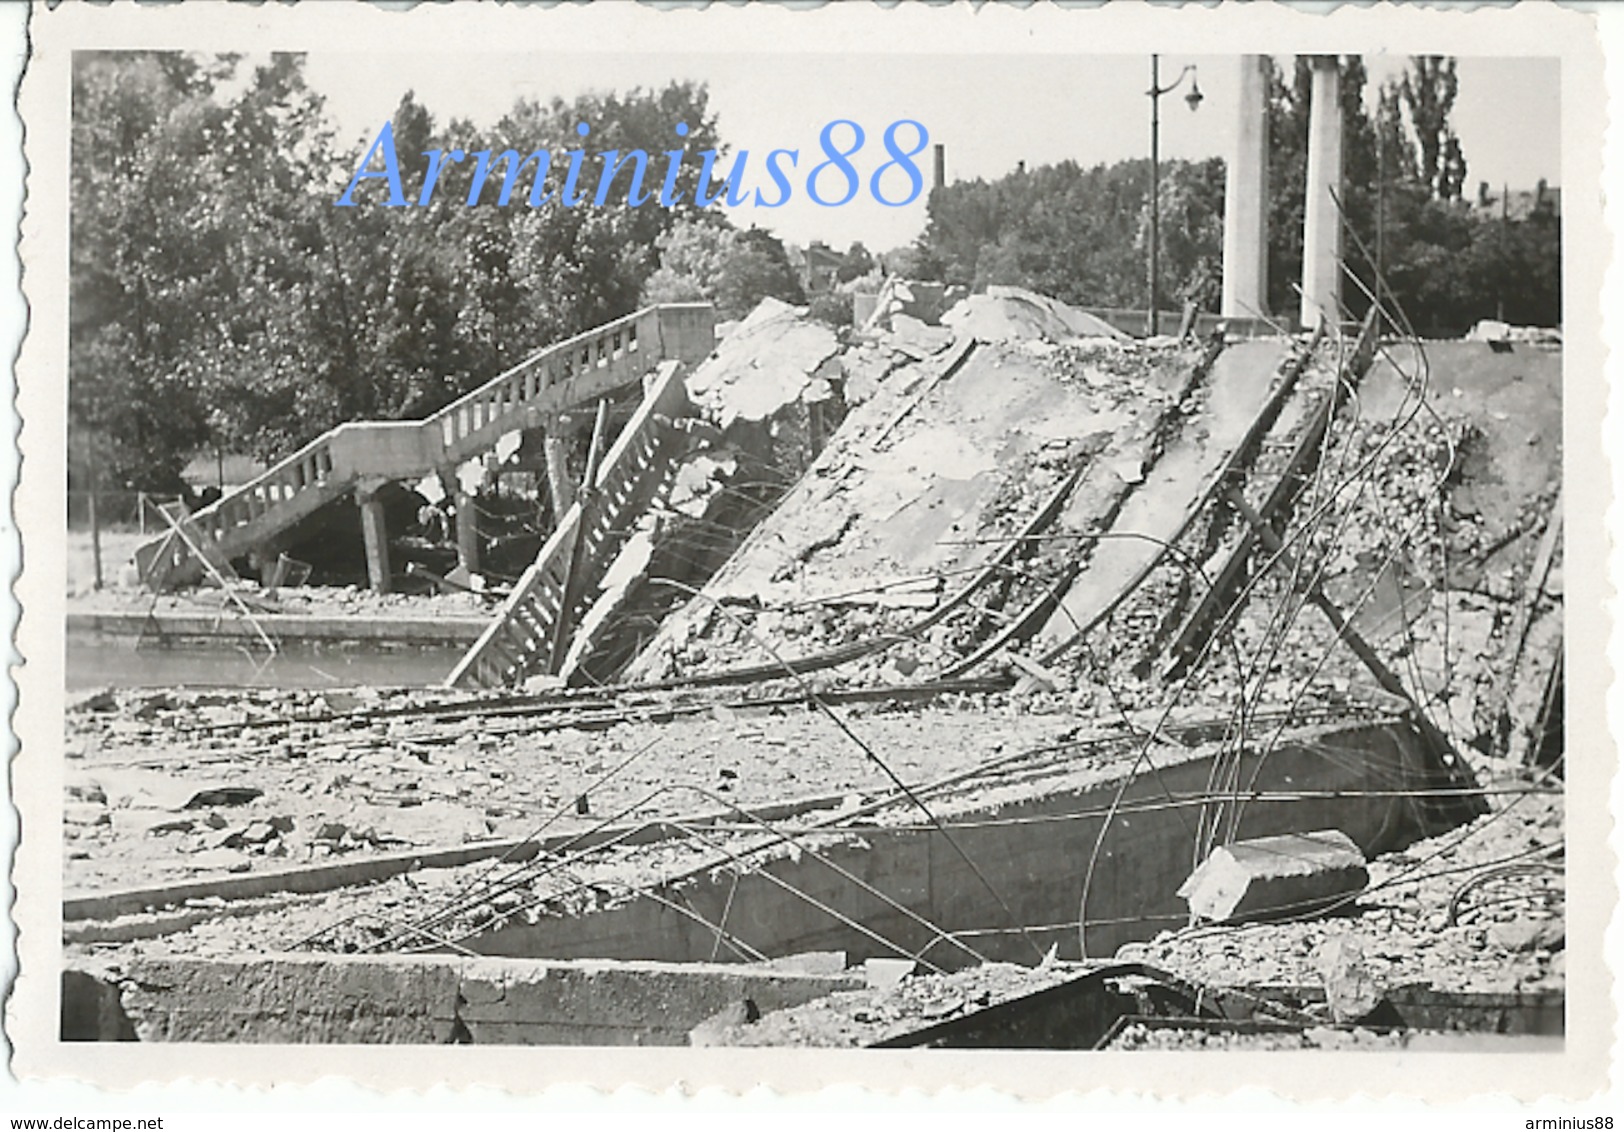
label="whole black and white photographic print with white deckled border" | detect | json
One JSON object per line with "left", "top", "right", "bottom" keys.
{"left": 13, "top": 3, "right": 1614, "bottom": 1096}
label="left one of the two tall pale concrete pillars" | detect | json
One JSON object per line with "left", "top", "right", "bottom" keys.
{"left": 1223, "top": 55, "right": 1268, "bottom": 318}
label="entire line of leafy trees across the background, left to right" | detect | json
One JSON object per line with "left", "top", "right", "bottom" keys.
{"left": 68, "top": 52, "right": 1561, "bottom": 492}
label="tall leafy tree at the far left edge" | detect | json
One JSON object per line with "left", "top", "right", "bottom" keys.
{"left": 70, "top": 52, "right": 325, "bottom": 490}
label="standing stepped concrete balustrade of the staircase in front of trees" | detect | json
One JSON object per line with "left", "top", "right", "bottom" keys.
{"left": 135, "top": 304, "right": 715, "bottom": 590}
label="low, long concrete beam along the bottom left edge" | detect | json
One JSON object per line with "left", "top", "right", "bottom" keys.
{"left": 63, "top": 955, "right": 864, "bottom": 1046}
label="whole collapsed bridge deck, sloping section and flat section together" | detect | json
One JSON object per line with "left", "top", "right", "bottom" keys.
{"left": 67, "top": 287, "right": 1561, "bottom": 1039}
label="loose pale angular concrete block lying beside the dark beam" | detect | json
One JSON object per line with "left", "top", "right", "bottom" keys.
{"left": 1179, "top": 830, "right": 1371, "bottom": 924}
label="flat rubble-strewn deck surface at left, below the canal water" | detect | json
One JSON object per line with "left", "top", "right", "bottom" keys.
{"left": 63, "top": 678, "right": 1097, "bottom": 890}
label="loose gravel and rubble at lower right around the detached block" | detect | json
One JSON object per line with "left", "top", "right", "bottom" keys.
{"left": 685, "top": 773, "right": 1566, "bottom": 1049}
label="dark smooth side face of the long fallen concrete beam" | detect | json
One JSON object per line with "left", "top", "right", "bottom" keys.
{"left": 474, "top": 719, "right": 1436, "bottom": 968}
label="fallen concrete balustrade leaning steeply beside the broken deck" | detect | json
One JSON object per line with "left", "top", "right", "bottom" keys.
{"left": 447, "top": 362, "right": 689, "bottom": 689}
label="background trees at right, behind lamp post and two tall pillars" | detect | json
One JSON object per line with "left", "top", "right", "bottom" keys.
{"left": 887, "top": 55, "right": 1562, "bottom": 336}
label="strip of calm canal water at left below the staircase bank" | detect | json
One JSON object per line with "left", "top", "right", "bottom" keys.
{"left": 67, "top": 633, "right": 464, "bottom": 692}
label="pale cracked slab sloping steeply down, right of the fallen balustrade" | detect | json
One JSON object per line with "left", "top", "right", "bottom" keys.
{"left": 625, "top": 282, "right": 1200, "bottom": 682}
